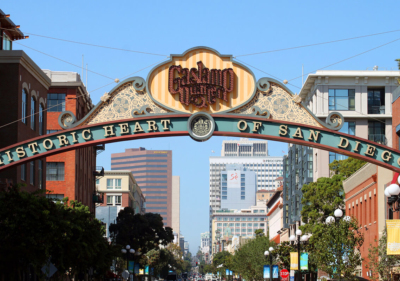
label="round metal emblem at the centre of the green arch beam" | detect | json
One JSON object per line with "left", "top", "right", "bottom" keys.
{"left": 188, "top": 112, "right": 215, "bottom": 141}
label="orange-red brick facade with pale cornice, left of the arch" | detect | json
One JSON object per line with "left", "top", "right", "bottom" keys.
{"left": 45, "top": 70, "right": 96, "bottom": 213}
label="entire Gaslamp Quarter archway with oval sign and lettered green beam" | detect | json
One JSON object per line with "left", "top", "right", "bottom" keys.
{"left": 0, "top": 47, "right": 400, "bottom": 172}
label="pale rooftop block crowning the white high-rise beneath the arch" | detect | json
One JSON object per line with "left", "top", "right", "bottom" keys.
{"left": 221, "top": 138, "right": 268, "bottom": 157}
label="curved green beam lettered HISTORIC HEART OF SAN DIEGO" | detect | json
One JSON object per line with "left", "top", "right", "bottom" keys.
{"left": 0, "top": 114, "right": 400, "bottom": 172}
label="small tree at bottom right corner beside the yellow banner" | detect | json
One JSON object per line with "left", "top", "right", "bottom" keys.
{"left": 367, "top": 229, "right": 400, "bottom": 281}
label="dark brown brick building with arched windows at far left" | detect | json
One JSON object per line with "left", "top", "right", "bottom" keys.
{"left": 0, "top": 18, "right": 51, "bottom": 191}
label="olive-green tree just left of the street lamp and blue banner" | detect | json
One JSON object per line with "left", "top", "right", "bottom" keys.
{"left": 230, "top": 236, "right": 276, "bottom": 280}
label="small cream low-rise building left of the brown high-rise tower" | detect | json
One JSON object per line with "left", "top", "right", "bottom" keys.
{"left": 96, "top": 168, "right": 146, "bottom": 237}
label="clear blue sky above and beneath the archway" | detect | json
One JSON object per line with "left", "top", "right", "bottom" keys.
{"left": 4, "top": 0, "right": 400, "bottom": 253}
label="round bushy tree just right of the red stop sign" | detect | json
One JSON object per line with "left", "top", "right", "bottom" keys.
{"left": 311, "top": 218, "right": 364, "bottom": 280}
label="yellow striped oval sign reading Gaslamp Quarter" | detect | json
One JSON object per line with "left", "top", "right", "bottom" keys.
{"left": 147, "top": 47, "right": 256, "bottom": 113}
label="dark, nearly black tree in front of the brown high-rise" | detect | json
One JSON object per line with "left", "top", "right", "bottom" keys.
{"left": 110, "top": 207, "right": 174, "bottom": 253}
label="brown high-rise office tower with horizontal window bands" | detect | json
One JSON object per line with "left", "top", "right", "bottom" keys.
{"left": 111, "top": 147, "right": 172, "bottom": 226}
